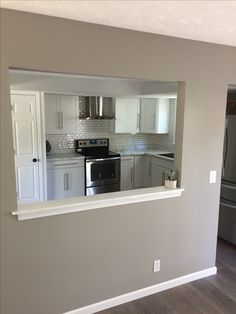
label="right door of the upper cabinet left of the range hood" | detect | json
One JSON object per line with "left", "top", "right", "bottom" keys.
{"left": 59, "top": 95, "right": 78, "bottom": 133}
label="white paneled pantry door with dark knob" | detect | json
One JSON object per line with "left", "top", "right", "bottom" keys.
{"left": 11, "top": 92, "right": 43, "bottom": 204}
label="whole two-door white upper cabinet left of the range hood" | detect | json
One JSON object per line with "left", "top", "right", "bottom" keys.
{"left": 44, "top": 94, "right": 78, "bottom": 134}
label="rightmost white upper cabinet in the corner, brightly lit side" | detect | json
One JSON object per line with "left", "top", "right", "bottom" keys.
{"left": 139, "top": 98, "right": 170, "bottom": 134}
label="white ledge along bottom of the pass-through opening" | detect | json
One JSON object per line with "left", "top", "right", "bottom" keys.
{"left": 12, "top": 186, "right": 184, "bottom": 220}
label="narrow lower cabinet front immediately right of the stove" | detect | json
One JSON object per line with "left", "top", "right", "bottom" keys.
{"left": 120, "top": 157, "right": 134, "bottom": 191}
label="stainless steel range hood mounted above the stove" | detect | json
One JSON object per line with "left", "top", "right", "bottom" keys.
{"left": 80, "top": 96, "right": 112, "bottom": 120}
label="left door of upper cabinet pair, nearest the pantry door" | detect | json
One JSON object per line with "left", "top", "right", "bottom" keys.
{"left": 44, "top": 94, "right": 61, "bottom": 134}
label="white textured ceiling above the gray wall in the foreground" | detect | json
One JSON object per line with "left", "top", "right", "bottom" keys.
{"left": 0, "top": 0, "right": 236, "bottom": 46}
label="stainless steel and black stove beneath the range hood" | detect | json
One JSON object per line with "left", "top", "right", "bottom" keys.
{"left": 75, "top": 139, "right": 120, "bottom": 195}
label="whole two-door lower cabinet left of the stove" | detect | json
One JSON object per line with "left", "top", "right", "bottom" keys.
{"left": 47, "top": 159, "right": 84, "bottom": 200}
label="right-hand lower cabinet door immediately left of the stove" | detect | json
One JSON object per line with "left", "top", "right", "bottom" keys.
{"left": 65, "top": 167, "right": 85, "bottom": 197}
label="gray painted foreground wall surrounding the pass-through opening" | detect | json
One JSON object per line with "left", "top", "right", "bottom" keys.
{"left": 1, "top": 10, "right": 236, "bottom": 314}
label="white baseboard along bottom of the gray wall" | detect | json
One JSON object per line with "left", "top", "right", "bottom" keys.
{"left": 64, "top": 267, "right": 217, "bottom": 314}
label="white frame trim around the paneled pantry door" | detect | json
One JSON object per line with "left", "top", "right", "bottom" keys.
{"left": 10, "top": 89, "right": 47, "bottom": 202}
